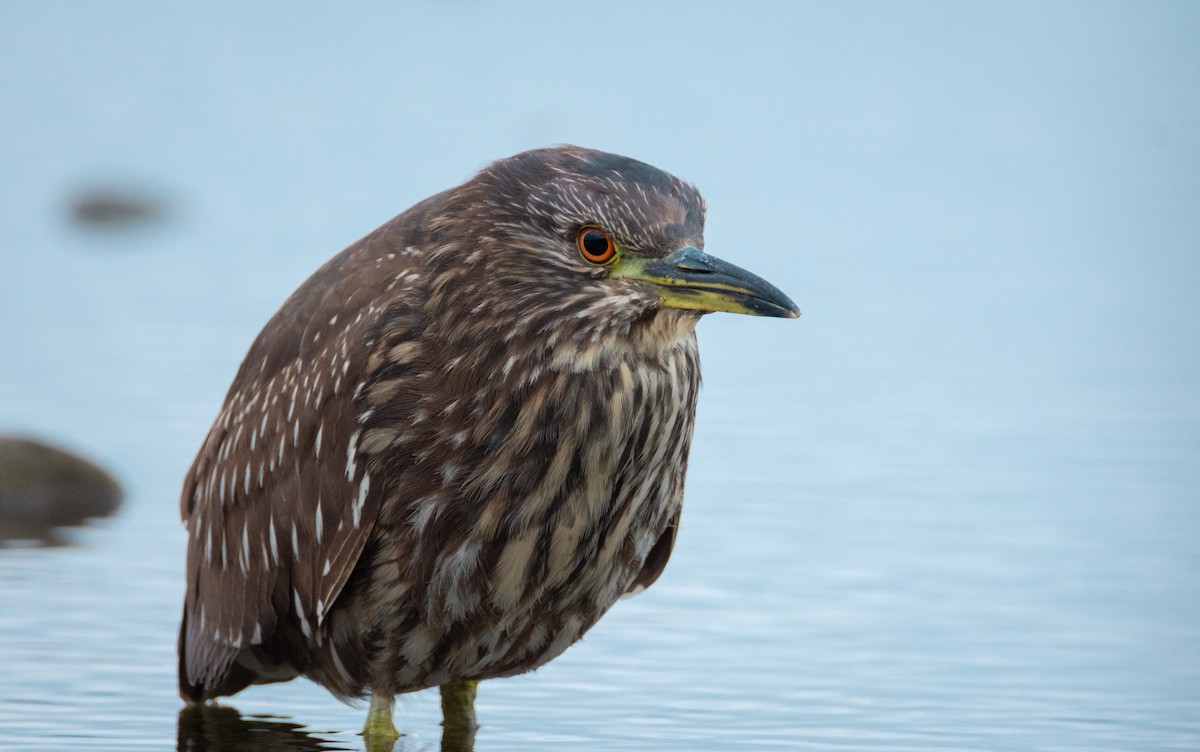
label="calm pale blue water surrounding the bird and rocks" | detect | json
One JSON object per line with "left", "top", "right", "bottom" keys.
{"left": 0, "top": 0, "right": 1200, "bottom": 751}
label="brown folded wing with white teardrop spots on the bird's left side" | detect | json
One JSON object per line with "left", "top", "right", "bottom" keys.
{"left": 180, "top": 217, "right": 415, "bottom": 700}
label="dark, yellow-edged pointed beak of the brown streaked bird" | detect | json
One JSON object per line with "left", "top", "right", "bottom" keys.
{"left": 613, "top": 246, "right": 800, "bottom": 319}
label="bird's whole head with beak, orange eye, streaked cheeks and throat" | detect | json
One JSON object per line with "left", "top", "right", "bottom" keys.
{"left": 425, "top": 146, "right": 800, "bottom": 367}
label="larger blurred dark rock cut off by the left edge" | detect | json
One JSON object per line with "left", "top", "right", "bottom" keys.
{"left": 0, "top": 437, "right": 122, "bottom": 546}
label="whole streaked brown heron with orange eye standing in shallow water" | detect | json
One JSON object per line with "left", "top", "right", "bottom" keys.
{"left": 178, "top": 145, "right": 800, "bottom": 738}
